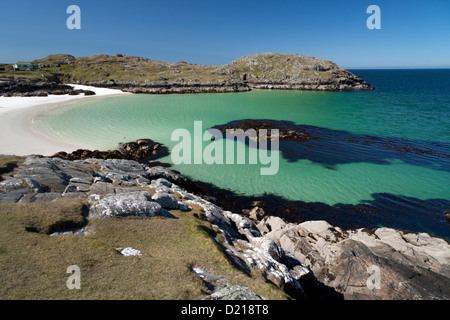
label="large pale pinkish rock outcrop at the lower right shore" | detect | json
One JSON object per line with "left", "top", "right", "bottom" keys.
{"left": 258, "top": 217, "right": 450, "bottom": 300}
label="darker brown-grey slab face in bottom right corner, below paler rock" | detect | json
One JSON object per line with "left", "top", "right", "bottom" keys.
{"left": 330, "top": 240, "right": 450, "bottom": 300}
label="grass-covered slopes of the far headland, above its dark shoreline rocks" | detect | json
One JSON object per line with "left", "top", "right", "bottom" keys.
{"left": 0, "top": 54, "right": 342, "bottom": 83}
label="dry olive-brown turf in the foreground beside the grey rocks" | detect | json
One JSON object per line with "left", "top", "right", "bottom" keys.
{"left": 0, "top": 200, "right": 286, "bottom": 300}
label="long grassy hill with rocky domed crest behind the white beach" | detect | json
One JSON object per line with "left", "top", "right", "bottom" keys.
{"left": 0, "top": 53, "right": 371, "bottom": 90}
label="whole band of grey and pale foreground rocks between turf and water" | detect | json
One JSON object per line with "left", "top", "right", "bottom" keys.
{"left": 0, "top": 140, "right": 450, "bottom": 300}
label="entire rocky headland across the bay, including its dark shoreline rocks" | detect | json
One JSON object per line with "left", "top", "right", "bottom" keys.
{"left": 0, "top": 53, "right": 374, "bottom": 95}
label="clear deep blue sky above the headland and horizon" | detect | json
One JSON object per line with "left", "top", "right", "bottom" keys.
{"left": 0, "top": 0, "right": 450, "bottom": 68}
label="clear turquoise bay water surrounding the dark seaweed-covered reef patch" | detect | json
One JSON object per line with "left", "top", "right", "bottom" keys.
{"left": 36, "top": 70, "right": 450, "bottom": 235}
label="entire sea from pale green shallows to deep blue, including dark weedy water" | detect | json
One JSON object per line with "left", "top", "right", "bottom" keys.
{"left": 34, "top": 69, "right": 450, "bottom": 240}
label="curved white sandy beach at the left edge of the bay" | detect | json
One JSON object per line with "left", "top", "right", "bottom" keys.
{"left": 0, "top": 85, "right": 130, "bottom": 156}
